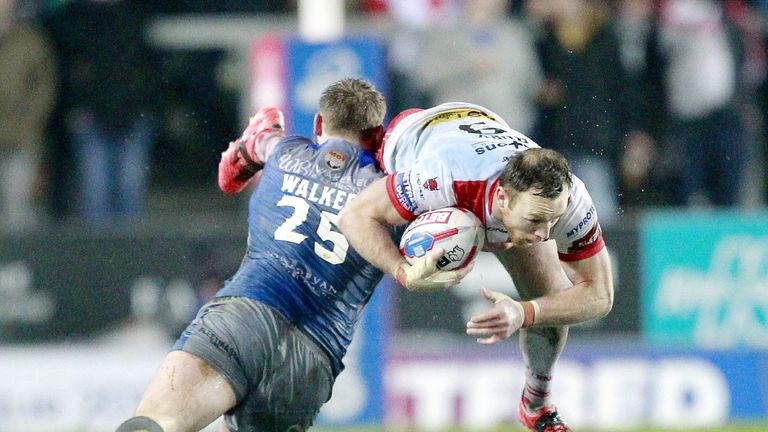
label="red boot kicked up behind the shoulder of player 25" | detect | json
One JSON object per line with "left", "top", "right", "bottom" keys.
{"left": 219, "top": 107, "right": 285, "bottom": 195}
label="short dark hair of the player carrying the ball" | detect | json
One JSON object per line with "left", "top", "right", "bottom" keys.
{"left": 499, "top": 148, "right": 573, "bottom": 198}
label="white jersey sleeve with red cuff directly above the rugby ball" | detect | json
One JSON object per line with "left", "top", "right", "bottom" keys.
{"left": 387, "top": 158, "right": 456, "bottom": 221}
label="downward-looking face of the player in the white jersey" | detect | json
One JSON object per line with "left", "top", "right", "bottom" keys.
{"left": 499, "top": 187, "right": 569, "bottom": 246}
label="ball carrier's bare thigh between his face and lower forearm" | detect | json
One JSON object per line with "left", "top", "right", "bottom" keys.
{"left": 495, "top": 241, "right": 571, "bottom": 299}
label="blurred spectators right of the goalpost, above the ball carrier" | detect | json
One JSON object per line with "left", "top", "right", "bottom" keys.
{"left": 376, "top": 0, "right": 768, "bottom": 225}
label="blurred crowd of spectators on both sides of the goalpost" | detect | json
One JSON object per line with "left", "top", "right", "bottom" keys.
{"left": 0, "top": 0, "right": 768, "bottom": 231}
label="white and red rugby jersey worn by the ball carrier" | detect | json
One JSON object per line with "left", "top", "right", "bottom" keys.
{"left": 382, "top": 102, "right": 605, "bottom": 261}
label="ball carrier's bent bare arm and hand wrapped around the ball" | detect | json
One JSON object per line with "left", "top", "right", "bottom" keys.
{"left": 338, "top": 177, "right": 472, "bottom": 290}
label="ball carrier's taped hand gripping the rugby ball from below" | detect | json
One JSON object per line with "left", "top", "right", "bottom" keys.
{"left": 395, "top": 248, "right": 475, "bottom": 291}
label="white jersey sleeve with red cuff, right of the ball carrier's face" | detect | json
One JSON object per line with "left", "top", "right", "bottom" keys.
{"left": 553, "top": 177, "right": 605, "bottom": 261}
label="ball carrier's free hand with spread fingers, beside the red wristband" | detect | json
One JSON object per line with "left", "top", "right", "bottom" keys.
{"left": 467, "top": 288, "right": 525, "bottom": 345}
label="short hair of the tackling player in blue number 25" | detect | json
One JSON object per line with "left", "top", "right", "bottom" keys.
{"left": 318, "top": 78, "right": 387, "bottom": 134}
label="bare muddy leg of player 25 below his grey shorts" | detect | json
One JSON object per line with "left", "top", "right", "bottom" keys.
{"left": 136, "top": 351, "right": 235, "bottom": 432}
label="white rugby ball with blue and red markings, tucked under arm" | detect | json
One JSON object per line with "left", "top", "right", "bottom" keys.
{"left": 400, "top": 207, "right": 485, "bottom": 270}
